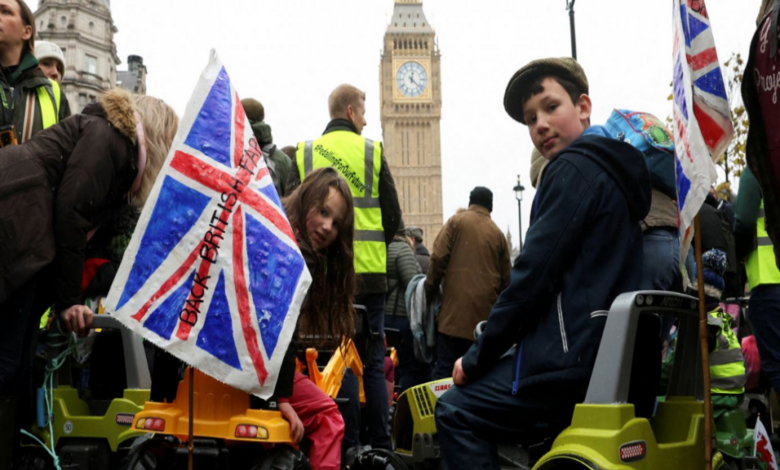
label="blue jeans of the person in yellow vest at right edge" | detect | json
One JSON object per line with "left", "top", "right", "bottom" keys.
{"left": 748, "top": 284, "right": 780, "bottom": 393}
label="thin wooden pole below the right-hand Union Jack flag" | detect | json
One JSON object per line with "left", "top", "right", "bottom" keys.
{"left": 693, "top": 214, "right": 712, "bottom": 470}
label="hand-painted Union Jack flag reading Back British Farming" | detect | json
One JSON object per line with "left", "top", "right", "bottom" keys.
{"left": 107, "top": 51, "right": 311, "bottom": 398}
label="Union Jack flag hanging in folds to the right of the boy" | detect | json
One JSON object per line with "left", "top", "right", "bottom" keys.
{"left": 673, "top": 0, "right": 734, "bottom": 260}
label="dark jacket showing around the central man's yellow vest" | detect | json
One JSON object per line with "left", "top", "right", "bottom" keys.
{"left": 287, "top": 119, "right": 401, "bottom": 295}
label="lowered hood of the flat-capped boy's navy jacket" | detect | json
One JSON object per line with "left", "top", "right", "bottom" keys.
{"left": 550, "top": 132, "right": 652, "bottom": 222}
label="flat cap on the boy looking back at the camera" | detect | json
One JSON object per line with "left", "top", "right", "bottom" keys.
{"left": 504, "top": 57, "right": 588, "bottom": 124}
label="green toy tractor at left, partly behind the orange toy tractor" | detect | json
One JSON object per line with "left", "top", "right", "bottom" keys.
{"left": 25, "top": 315, "right": 151, "bottom": 470}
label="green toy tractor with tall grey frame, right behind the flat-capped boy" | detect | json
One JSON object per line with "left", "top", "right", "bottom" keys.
{"left": 533, "top": 291, "right": 724, "bottom": 470}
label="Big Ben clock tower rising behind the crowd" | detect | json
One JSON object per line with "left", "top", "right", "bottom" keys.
{"left": 380, "top": 0, "right": 443, "bottom": 248}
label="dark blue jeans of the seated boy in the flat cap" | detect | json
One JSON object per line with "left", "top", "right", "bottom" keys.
{"left": 436, "top": 355, "right": 587, "bottom": 470}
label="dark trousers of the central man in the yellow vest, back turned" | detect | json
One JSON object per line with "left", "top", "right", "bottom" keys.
{"left": 354, "top": 294, "right": 392, "bottom": 449}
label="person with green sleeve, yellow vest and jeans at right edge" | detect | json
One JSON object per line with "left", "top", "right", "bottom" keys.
{"left": 734, "top": 167, "right": 780, "bottom": 393}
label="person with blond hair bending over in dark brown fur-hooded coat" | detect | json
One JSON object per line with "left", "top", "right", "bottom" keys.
{"left": 0, "top": 89, "right": 178, "bottom": 462}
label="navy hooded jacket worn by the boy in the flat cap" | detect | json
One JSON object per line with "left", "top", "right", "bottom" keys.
{"left": 462, "top": 132, "right": 651, "bottom": 393}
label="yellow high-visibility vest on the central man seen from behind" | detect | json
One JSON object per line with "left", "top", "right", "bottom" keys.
{"left": 295, "top": 131, "right": 387, "bottom": 274}
